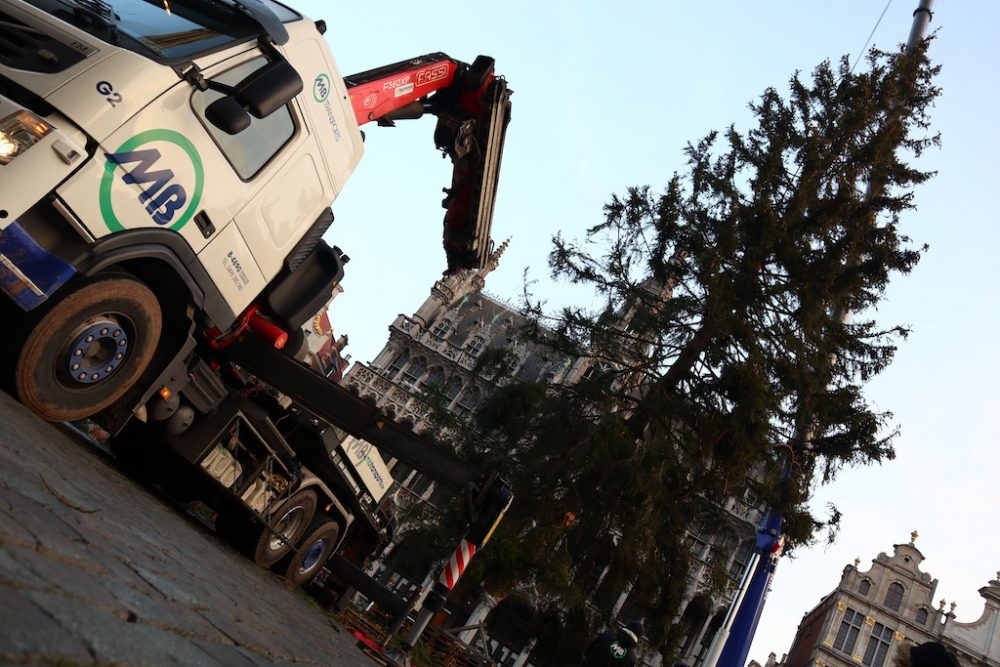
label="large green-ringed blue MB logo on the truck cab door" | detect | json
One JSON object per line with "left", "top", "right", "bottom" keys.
{"left": 99, "top": 130, "right": 205, "bottom": 232}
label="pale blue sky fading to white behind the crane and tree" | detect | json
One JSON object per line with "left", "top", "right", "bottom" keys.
{"left": 289, "top": 0, "right": 1000, "bottom": 662}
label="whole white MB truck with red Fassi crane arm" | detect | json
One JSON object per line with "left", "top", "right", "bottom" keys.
{"left": 0, "top": 0, "right": 512, "bottom": 648}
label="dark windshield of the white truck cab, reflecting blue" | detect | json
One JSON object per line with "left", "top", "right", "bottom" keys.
{"left": 31, "top": 0, "right": 299, "bottom": 63}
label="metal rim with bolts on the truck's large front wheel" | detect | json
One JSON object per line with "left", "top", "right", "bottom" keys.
{"left": 60, "top": 315, "right": 130, "bottom": 385}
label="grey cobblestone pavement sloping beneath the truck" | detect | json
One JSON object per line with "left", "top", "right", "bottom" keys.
{"left": 0, "top": 392, "right": 374, "bottom": 667}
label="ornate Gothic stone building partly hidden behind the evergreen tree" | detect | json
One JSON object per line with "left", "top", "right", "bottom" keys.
{"left": 342, "top": 243, "right": 762, "bottom": 667}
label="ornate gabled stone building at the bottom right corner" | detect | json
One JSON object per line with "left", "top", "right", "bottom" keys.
{"left": 781, "top": 532, "right": 1000, "bottom": 667}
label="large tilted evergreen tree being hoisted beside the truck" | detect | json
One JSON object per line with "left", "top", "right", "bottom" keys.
{"left": 434, "top": 43, "right": 939, "bottom": 664}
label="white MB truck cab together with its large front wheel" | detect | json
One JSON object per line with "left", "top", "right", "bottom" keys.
{"left": 0, "top": 0, "right": 363, "bottom": 419}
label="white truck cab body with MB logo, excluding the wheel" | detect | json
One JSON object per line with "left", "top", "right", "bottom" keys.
{"left": 0, "top": 0, "right": 362, "bottom": 314}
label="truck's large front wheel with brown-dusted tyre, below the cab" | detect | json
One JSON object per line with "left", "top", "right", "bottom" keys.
{"left": 14, "top": 276, "right": 163, "bottom": 421}
